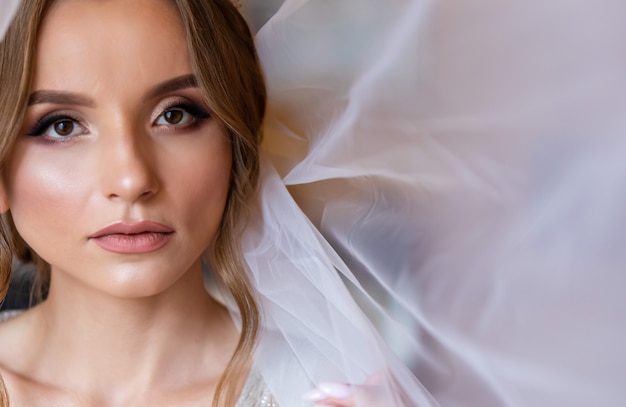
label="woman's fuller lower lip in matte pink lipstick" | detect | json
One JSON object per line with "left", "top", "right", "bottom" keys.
{"left": 91, "top": 232, "right": 172, "bottom": 254}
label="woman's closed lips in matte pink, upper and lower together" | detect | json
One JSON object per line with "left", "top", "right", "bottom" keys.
{"left": 89, "top": 220, "right": 174, "bottom": 254}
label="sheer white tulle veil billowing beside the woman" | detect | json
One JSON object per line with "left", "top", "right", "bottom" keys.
{"left": 0, "top": 0, "right": 626, "bottom": 407}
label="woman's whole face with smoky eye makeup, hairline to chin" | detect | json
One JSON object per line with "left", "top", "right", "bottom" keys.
{"left": 3, "top": 0, "right": 231, "bottom": 297}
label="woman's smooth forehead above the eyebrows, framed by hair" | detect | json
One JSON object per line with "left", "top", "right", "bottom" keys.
{"left": 34, "top": 0, "right": 191, "bottom": 92}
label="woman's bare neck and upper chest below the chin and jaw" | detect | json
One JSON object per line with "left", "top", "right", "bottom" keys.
{"left": 25, "top": 262, "right": 238, "bottom": 404}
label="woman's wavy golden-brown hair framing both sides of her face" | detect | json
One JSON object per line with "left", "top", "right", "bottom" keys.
{"left": 0, "top": 0, "right": 266, "bottom": 407}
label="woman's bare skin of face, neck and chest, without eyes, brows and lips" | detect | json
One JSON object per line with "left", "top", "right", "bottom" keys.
{"left": 0, "top": 0, "right": 238, "bottom": 406}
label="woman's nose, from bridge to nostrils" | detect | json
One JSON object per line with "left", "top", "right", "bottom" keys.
{"left": 98, "top": 122, "right": 160, "bottom": 203}
